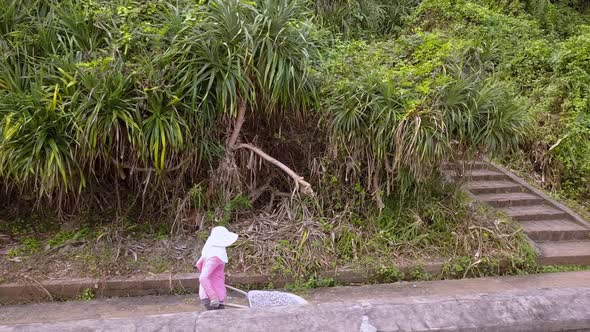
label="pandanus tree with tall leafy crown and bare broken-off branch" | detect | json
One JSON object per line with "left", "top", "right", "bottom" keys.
{"left": 168, "top": 0, "right": 315, "bottom": 198}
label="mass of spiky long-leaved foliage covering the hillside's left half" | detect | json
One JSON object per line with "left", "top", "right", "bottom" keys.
{"left": 0, "top": 0, "right": 313, "bottom": 208}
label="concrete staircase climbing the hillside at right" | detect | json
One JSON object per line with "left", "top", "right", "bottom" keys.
{"left": 444, "top": 161, "right": 590, "bottom": 265}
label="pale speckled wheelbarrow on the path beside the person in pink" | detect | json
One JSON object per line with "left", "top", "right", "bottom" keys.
{"left": 224, "top": 285, "right": 308, "bottom": 308}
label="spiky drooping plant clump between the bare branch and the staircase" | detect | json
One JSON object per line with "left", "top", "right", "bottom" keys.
{"left": 322, "top": 36, "right": 527, "bottom": 200}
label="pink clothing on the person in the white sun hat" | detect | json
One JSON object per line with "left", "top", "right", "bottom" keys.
{"left": 196, "top": 256, "right": 226, "bottom": 302}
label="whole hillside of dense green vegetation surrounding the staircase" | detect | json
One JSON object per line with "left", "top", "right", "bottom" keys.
{"left": 0, "top": 0, "right": 590, "bottom": 282}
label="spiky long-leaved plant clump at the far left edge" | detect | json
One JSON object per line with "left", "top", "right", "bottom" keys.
{"left": 0, "top": 57, "right": 84, "bottom": 198}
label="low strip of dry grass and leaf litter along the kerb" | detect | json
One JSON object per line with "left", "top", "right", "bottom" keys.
{"left": 0, "top": 178, "right": 535, "bottom": 288}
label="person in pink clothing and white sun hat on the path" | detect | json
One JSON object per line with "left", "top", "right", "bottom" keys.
{"left": 195, "top": 226, "right": 238, "bottom": 310}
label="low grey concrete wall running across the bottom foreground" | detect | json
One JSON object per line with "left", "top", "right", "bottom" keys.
{"left": 0, "top": 288, "right": 590, "bottom": 332}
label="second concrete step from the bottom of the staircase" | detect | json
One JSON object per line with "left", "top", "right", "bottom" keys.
{"left": 520, "top": 219, "right": 590, "bottom": 241}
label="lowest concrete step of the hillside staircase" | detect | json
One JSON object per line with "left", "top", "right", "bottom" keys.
{"left": 537, "top": 240, "right": 590, "bottom": 265}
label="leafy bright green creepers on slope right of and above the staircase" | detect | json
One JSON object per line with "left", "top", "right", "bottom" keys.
{"left": 412, "top": 1, "right": 590, "bottom": 207}
